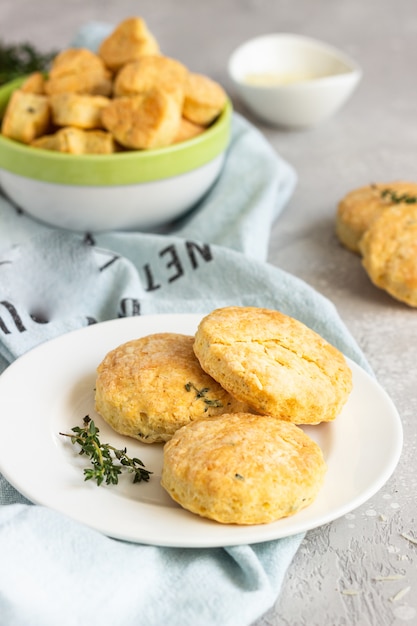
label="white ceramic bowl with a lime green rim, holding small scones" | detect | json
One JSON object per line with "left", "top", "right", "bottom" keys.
{"left": 0, "top": 79, "right": 232, "bottom": 231}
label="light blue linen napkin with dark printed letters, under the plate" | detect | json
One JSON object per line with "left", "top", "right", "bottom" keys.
{"left": 0, "top": 22, "right": 367, "bottom": 626}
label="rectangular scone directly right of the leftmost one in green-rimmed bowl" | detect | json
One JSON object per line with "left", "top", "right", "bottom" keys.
{"left": 50, "top": 93, "right": 110, "bottom": 129}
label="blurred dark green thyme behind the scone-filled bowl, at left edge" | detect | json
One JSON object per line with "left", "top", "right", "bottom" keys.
{"left": 0, "top": 40, "right": 57, "bottom": 85}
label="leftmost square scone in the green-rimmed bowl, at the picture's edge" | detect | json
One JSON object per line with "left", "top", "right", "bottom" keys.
{"left": 1, "top": 89, "right": 51, "bottom": 144}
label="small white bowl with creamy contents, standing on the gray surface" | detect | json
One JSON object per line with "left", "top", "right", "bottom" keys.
{"left": 228, "top": 33, "right": 362, "bottom": 129}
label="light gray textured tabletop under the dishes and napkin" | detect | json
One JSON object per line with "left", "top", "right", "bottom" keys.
{"left": 0, "top": 0, "right": 417, "bottom": 626}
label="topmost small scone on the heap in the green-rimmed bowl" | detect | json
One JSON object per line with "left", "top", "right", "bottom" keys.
{"left": 99, "top": 17, "right": 159, "bottom": 71}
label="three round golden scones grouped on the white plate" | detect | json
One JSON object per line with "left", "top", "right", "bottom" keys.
{"left": 96, "top": 307, "right": 352, "bottom": 524}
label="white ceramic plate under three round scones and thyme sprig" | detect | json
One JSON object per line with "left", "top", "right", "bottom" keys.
{"left": 0, "top": 315, "right": 402, "bottom": 547}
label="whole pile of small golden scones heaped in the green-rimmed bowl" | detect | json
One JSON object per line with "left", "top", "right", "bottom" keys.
{"left": 2, "top": 17, "right": 227, "bottom": 154}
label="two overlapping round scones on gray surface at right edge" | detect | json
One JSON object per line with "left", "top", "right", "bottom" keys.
{"left": 336, "top": 181, "right": 417, "bottom": 307}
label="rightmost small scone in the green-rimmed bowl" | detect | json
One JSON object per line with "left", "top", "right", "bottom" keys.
{"left": 182, "top": 72, "right": 227, "bottom": 126}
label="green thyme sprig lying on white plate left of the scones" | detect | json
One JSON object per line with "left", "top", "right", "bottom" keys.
{"left": 59, "top": 415, "right": 152, "bottom": 486}
